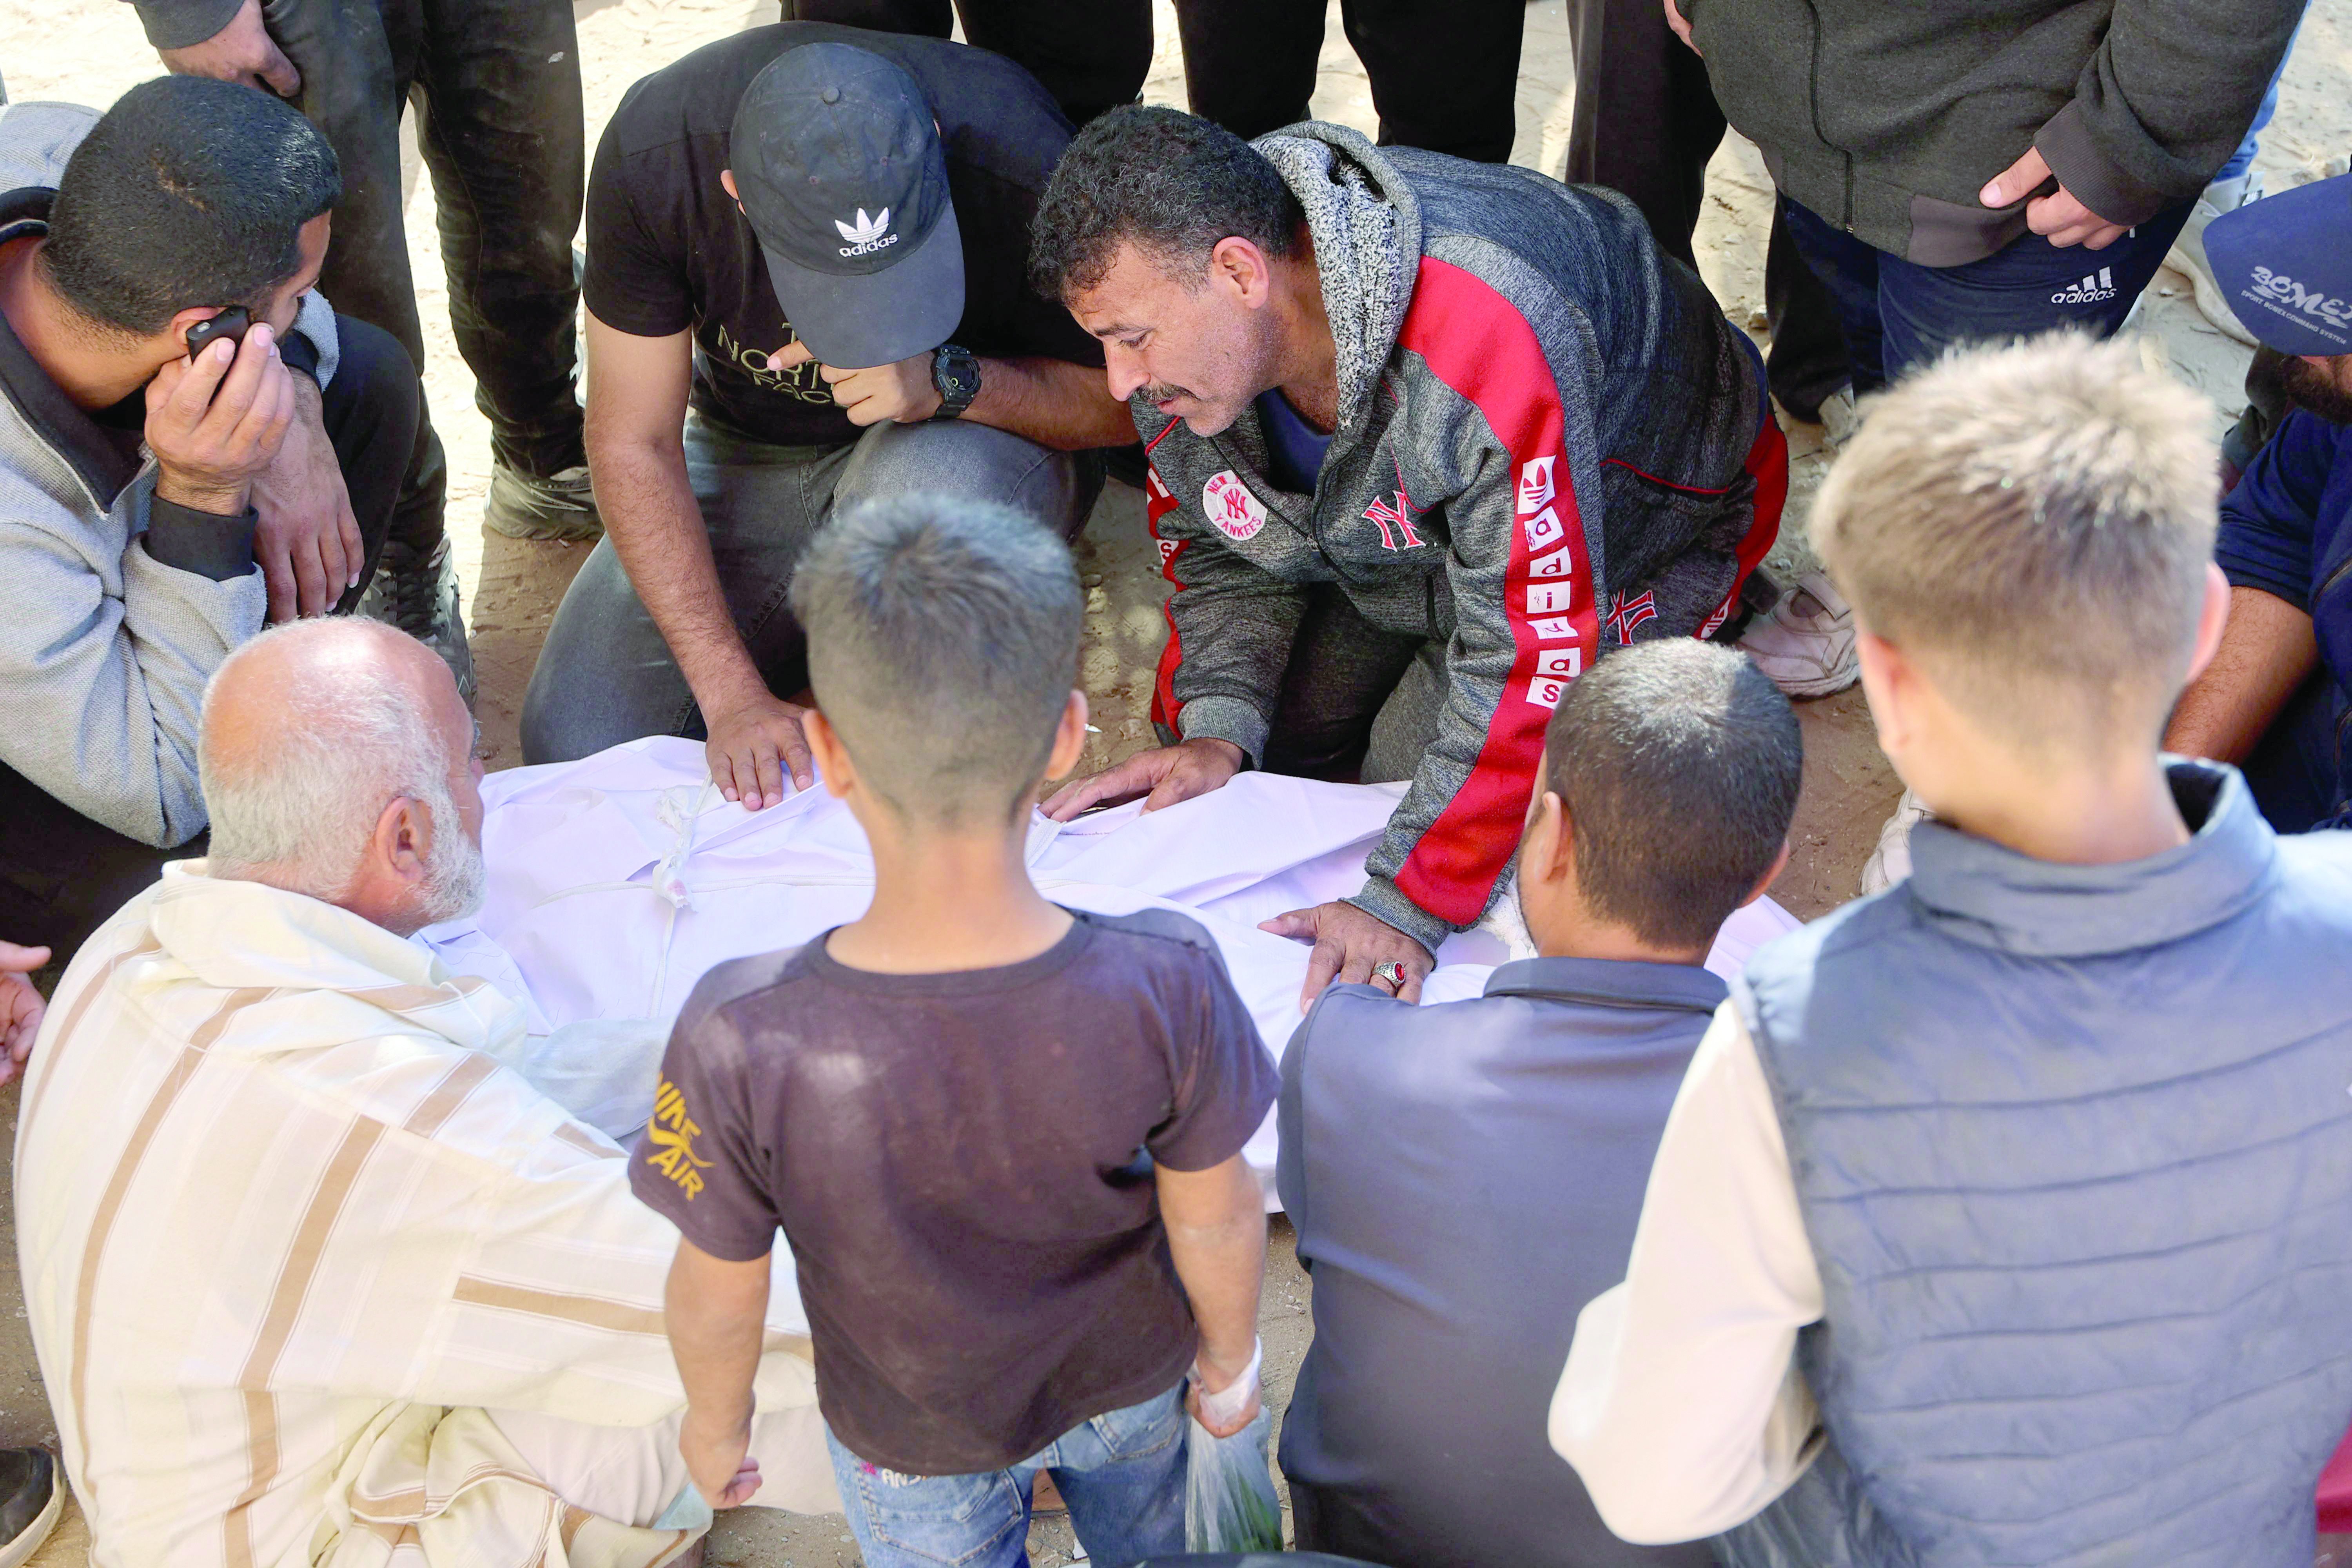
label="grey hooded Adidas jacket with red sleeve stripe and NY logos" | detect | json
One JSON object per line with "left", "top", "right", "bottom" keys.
{"left": 1134, "top": 125, "right": 1788, "bottom": 947}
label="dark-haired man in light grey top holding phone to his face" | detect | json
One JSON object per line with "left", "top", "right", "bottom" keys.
{"left": 0, "top": 78, "right": 419, "bottom": 957}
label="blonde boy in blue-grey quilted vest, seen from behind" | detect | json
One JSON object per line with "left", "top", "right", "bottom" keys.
{"left": 1552, "top": 336, "right": 2352, "bottom": 1568}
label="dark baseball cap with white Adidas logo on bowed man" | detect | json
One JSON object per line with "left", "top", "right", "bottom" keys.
{"left": 727, "top": 42, "right": 964, "bottom": 369}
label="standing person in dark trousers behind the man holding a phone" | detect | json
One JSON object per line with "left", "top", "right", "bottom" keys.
{"left": 136, "top": 0, "right": 602, "bottom": 701}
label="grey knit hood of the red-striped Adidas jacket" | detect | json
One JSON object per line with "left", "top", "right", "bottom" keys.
{"left": 1251, "top": 120, "right": 1421, "bottom": 430}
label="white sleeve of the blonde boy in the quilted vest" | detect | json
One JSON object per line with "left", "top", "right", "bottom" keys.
{"left": 1550, "top": 1002, "right": 1820, "bottom": 1544}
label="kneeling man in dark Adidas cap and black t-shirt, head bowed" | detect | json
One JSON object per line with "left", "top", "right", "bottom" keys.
{"left": 522, "top": 21, "right": 1136, "bottom": 811}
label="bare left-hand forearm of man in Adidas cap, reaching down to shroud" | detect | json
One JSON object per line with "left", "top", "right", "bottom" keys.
{"left": 588, "top": 428, "right": 767, "bottom": 712}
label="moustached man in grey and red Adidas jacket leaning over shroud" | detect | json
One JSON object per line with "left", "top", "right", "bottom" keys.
{"left": 1030, "top": 108, "right": 1788, "bottom": 997}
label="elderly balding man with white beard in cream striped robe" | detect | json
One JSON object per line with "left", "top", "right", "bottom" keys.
{"left": 16, "top": 621, "right": 840, "bottom": 1568}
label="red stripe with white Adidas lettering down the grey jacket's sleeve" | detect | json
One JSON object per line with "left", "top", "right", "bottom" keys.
{"left": 1397, "top": 256, "right": 1599, "bottom": 926}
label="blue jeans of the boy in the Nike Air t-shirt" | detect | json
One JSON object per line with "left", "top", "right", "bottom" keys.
{"left": 826, "top": 1382, "right": 1185, "bottom": 1568}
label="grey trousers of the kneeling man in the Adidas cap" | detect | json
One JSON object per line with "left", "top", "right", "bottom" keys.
{"left": 522, "top": 414, "right": 1103, "bottom": 762}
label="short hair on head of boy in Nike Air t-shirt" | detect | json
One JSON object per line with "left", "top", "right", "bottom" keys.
{"left": 793, "top": 496, "right": 1084, "bottom": 828}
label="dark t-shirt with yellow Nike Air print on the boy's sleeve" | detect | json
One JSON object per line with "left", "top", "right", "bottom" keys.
{"left": 630, "top": 910, "right": 1279, "bottom": 1476}
